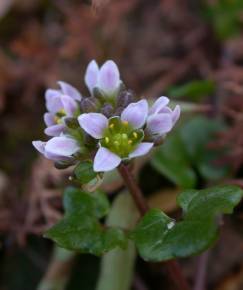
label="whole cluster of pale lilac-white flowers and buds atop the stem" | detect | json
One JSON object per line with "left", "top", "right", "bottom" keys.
{"left": 33, "top": 60, "right": 180, "bottom": 172}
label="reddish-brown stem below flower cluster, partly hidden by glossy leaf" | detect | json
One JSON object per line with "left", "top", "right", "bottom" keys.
{"left": 118, "top": 164, "right": 190, "bottom": 290}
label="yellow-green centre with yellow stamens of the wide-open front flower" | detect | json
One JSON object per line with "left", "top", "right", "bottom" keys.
{"left": 100, "top": 117, "right": 144, "bottom": 158}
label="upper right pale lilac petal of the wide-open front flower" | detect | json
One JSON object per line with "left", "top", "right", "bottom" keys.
{"left": 121, "top": 100, "right": 148, "bottom": 129}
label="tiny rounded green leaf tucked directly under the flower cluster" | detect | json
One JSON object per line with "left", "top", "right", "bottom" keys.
{"left": 74, "top": 161, "right": 97, "bottom": 184}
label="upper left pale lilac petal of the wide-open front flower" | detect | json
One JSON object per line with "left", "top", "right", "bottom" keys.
{"left": 78, "top": 113, "right": 108, "bottom": 139}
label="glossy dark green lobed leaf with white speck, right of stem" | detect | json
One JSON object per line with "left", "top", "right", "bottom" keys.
{"left": 133, "top": 186, "right": 243, "bottom": 261}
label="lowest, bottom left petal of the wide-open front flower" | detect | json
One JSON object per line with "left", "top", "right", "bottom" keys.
{"left": 94, "top": 147, "right": 121, "bottom": 172}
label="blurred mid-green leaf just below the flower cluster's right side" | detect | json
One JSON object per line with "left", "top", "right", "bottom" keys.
{"left": 151, "top": 134, "right": 196, "bottom": 188}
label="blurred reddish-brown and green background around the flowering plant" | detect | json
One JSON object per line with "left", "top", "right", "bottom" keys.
{"left": 0, "top": 0, "right": 243, "bottom": 290}
